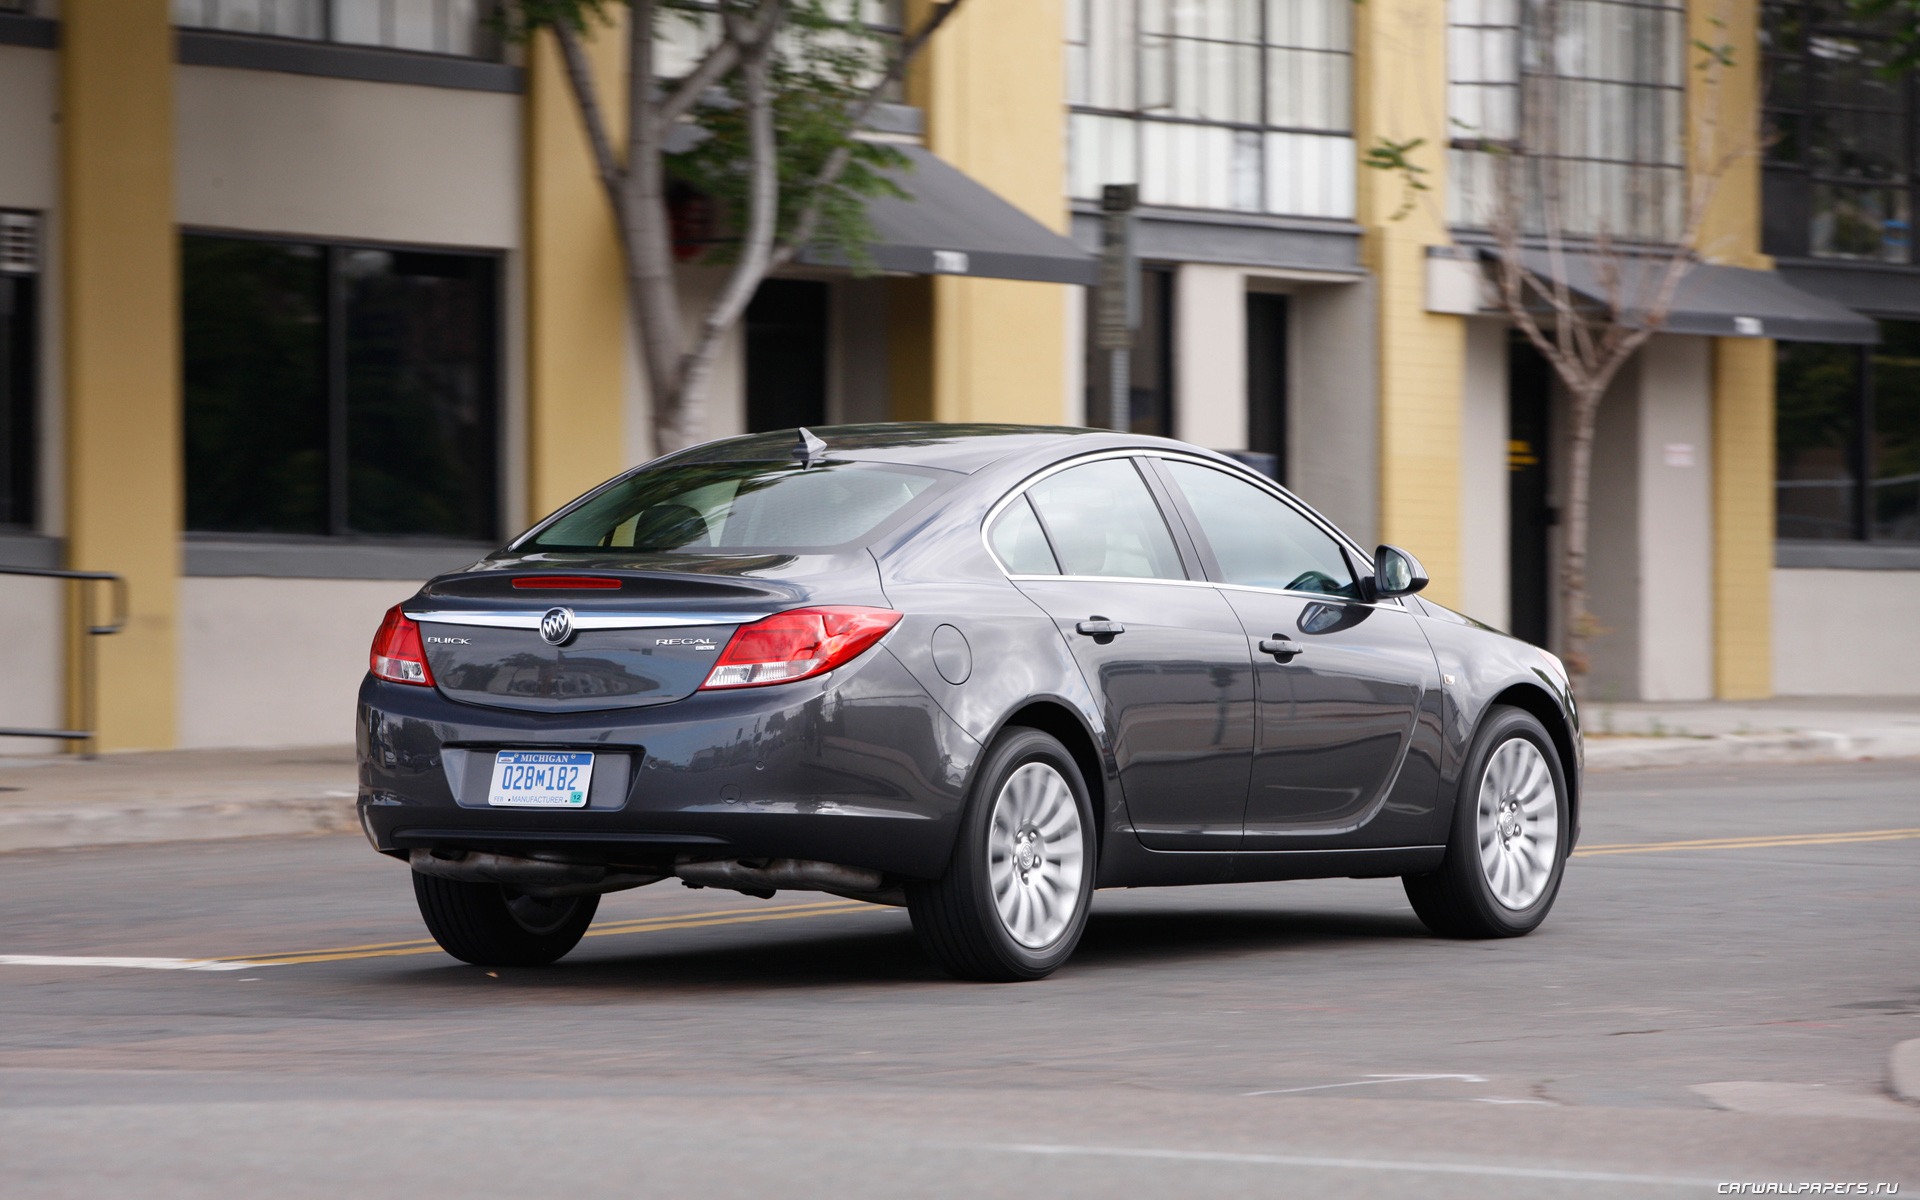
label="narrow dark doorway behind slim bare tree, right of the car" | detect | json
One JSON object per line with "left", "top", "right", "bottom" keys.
{"left": 1507, "top": 334, "right": 1557, "bottom": 645}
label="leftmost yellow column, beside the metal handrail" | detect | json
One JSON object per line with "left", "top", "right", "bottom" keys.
{"left": 60, "top": 0, "right": 182, "bottom": 751}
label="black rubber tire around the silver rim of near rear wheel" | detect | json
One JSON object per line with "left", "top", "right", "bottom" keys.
{"left": 906, "top": 728, "right": 1098, "bottom": 983}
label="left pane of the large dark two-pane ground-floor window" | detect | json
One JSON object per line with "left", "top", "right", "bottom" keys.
{"left": 180, "top": 236, "right": 326, "bottom": 534}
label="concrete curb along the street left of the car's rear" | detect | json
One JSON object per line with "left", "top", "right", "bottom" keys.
{"left": 0, "top": 795, "right": 359, "bottom": 852}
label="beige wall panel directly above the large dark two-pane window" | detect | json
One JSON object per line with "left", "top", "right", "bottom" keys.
{"left": 175, "top": 67, "right": 522, "bottom": 250}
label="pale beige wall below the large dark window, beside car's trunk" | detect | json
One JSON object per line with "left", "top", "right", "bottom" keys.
{"left": 179, "top": 578, "right": 417, "bottom": 747}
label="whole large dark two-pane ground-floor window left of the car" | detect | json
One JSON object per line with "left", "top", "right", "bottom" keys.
{"left": 180, "top": 234, "right": 499, "bottom": 541}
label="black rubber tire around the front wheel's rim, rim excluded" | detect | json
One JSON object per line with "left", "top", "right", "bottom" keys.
{"left": 1402, "top": 705, "right": 1572, "bottom": 937}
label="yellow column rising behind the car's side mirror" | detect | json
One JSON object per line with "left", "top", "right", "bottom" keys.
{"left": 1352, "top": 0, "right": 1467, "bottom": 605}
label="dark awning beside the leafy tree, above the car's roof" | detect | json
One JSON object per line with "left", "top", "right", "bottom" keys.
{"left": 799, "top": 146, "right": 1098, "bottom": 286}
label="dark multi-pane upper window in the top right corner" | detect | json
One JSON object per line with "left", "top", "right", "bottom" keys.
{"left": 1761, "top": 0, "right": 1920, "bottom": 263}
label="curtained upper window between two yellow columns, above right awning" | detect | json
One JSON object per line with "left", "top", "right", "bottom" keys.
{"left": 1448, "top": 0, "right": 1688, "bottom": 242}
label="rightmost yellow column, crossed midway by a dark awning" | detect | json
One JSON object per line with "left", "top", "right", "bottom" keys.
{"left": 1688, "top": 0, "right": 1774, "bottom": 699}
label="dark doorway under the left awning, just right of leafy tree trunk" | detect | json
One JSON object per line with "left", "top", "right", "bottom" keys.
{"left": 747, "top": 278, "right": 831, "bottom": 434}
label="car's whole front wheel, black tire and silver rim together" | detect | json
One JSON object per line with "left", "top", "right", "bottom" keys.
{"left": 1402, "top": 705, "right": 1572, "bottom": 937}
